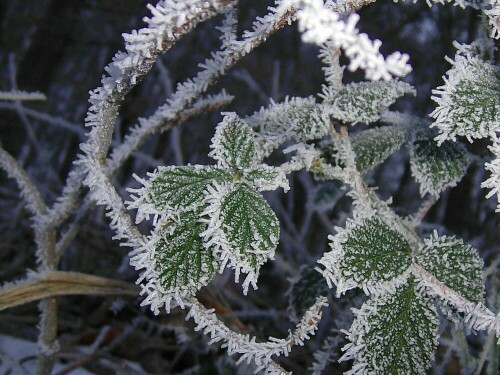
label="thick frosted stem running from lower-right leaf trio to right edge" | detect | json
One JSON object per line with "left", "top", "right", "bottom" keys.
{"left": 411, "top": 263, "right": 500, "bottom": 339}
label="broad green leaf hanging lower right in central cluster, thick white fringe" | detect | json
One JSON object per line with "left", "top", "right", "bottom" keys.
{"left": 205, "top": 184, "right": 279, "bottom": 291}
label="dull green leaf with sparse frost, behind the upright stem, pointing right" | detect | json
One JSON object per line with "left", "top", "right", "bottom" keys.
{"left": 351, "top": 126, "right": 411, "bottom": 172}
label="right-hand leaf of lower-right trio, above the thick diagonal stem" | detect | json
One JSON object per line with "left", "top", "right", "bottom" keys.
{"left": 416, "top": 233, "right": 484, "bottom": 303}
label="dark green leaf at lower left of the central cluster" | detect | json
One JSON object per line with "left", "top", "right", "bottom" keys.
{"left": 154, "top": 211, "right": 217, "bottom": 296}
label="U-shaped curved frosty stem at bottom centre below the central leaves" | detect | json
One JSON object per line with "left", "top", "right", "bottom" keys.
{"left": 186, "top": 297, "right": 327, "bottom": 375}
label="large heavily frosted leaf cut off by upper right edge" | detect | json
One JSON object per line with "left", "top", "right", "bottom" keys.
{"left": 430, "top": 54, "right": 500, "bottom": 142}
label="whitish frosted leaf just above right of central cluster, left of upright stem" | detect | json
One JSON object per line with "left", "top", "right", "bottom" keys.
{"left": 245, "top": 97, "right": 330, "bottom": 157}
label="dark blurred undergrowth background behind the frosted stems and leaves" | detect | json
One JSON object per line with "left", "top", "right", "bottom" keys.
{"left": 0, "top": 0, "right": 500, "bottom": 374}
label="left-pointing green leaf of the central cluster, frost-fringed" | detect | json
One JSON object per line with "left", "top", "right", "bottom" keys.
{"left": 145, "top": 166, "right": 232, "bottom": 211}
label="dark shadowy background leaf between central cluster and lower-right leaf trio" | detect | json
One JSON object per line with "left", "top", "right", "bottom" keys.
{"left": 288, "top": 265, "right": 330, "bottom": 320}
